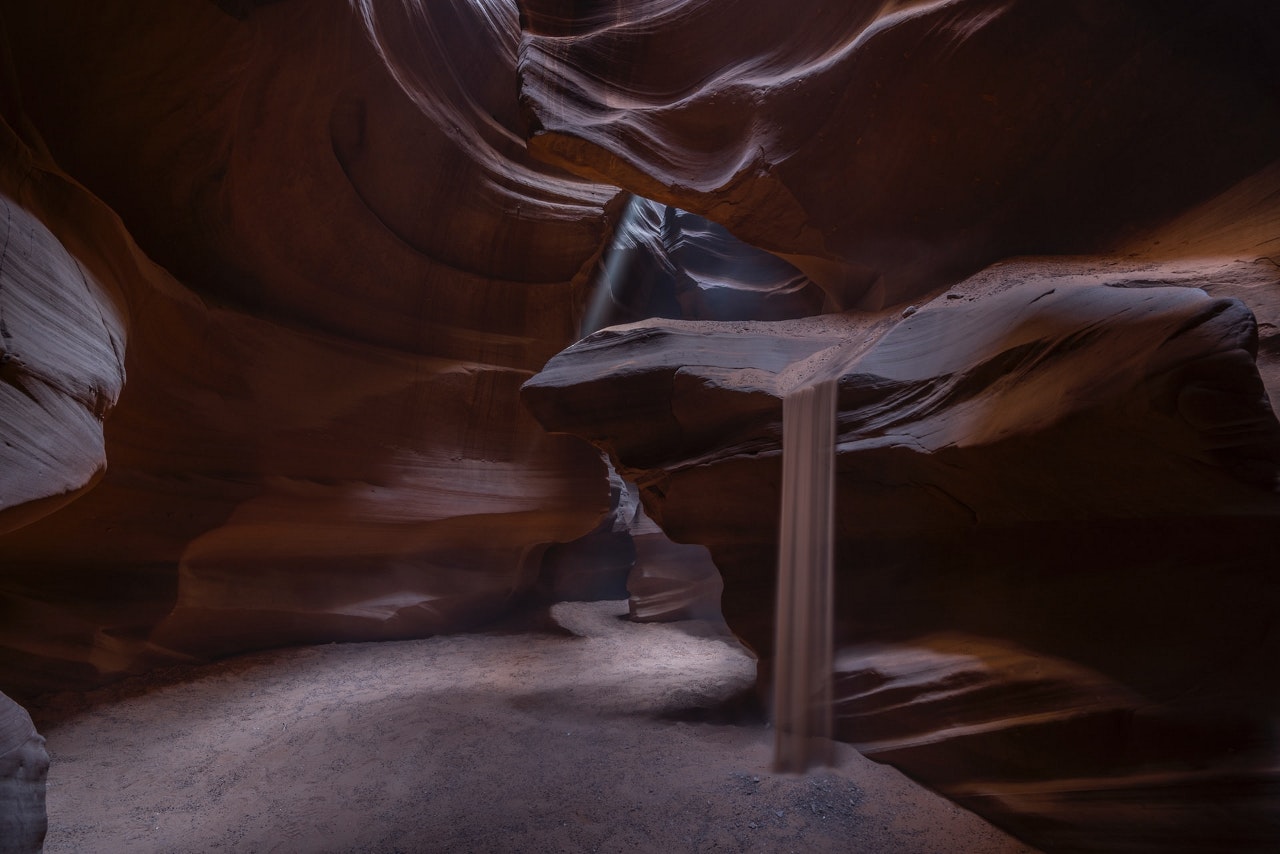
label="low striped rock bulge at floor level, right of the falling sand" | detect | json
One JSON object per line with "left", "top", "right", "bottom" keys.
{"left": 836, "top": 634, "right": 1280, "bottom": 853}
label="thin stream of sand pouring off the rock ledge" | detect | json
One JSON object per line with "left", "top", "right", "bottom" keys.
{"left": 773, "top": 379, "right": 837, "bottom": 772}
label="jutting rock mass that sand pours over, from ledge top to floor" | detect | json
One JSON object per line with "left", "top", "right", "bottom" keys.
{"left": 524, "top": 261, "right": 1280, "bottom": 851}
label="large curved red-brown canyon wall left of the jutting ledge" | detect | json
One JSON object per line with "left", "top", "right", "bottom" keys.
{"left": 0, "top": 0, "right": 617, "bottom": 693}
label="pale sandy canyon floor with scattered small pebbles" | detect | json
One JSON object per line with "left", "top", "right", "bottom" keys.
{"left": 33, "top": 602, "right": 1033, "bottom": 854}
